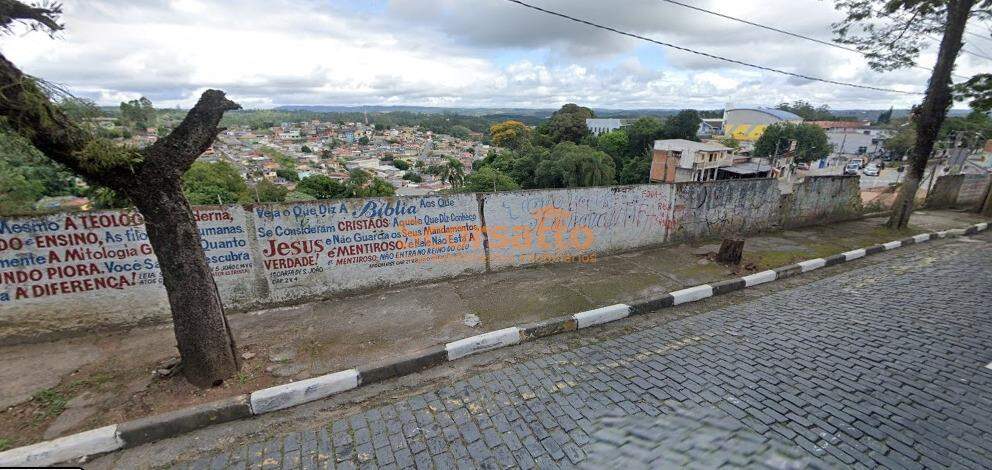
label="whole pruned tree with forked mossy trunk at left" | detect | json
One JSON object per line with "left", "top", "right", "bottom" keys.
{"left": 0, "top": 0, "right": 239, "bottom": 387}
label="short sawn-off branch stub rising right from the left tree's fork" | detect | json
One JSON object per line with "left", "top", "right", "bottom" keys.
{"left": 142, "top": 90, "right": 241, "bottom": 178}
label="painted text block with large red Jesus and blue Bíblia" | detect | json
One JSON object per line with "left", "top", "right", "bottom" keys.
{"left": 253, "top": 195, "right": 485, "bottom": 300}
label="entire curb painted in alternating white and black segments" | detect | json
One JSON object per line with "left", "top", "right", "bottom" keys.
{"left": 0, "top": 222, "right": 989, "bottom": 467}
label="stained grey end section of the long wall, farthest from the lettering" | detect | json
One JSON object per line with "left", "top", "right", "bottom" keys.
{"left": 781, "top": 176, "right": 864, "bottom": 228}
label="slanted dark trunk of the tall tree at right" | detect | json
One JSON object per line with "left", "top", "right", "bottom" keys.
{"left": 888, "top": 0, "right": 975, "bottom": 228}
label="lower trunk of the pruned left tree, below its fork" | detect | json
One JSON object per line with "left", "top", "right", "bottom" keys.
{"left": 129, "top": 182, "right": 239, "bottom": 387}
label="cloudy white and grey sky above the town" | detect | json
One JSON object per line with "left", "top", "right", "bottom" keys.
{"left": 0, "top": 0, "right": 992, "bottom": 109}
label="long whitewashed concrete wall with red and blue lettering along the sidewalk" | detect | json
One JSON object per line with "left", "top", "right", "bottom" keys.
{"left": 0, "top": 178, "right": 892, "bottom": 340}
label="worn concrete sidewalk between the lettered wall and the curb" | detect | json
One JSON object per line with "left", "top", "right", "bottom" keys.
{"left": 0, "top": 211, "right": 979, "bottom": 447}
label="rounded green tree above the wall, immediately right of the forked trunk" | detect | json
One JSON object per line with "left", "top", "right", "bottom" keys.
{"left": 182, "top": 162, "right": 248, "bottom": 204}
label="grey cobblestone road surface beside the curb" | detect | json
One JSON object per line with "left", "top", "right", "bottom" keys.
{"left": 181, "top": 236, "right": 992, "bottom": 468}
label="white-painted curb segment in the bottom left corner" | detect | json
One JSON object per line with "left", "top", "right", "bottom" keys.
{"left": 0, "top": 424, "right": 124, "bottom": 467}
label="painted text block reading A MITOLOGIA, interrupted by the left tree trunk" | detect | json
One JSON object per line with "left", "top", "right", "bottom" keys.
{"left": 0, "top": 207, "right": 252, "bottom": 304}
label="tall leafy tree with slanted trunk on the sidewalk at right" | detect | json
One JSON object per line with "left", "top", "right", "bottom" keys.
{"left": 834, "top": 0, "right": 992, "bottom": 228}
